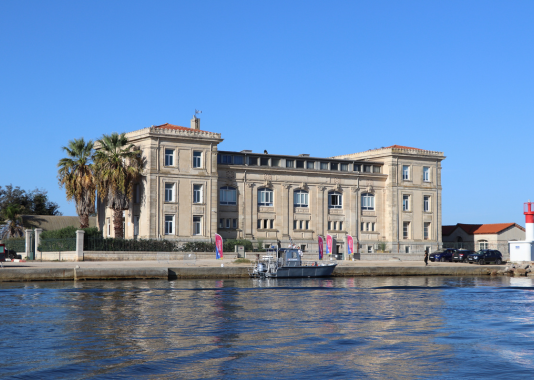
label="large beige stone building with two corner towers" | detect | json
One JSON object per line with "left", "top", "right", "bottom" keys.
{"left": 98, "top": 117, "right": 445, "bottom": 254}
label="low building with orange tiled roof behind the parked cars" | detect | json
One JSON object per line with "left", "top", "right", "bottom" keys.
{"left": 442, "top": 223, "right": 525, "bottom": 258}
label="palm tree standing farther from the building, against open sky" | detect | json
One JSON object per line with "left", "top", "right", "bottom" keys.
{"left": 57, "top": 137, "right": 96, "bottom": 228}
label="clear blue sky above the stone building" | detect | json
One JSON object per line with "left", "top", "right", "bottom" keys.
{"left": 0, "top": 0, "right": 534, "bottom": 225}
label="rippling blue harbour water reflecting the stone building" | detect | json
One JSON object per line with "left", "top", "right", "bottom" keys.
{"left": 0, "top": 277, "right": 534, "bottom": 379}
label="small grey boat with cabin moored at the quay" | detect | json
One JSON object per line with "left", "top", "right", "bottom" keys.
{"left": 249, "top": 248, "right": 337, "bottom": 278}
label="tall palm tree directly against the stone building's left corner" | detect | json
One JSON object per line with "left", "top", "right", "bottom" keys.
{"left": 94, "top": 132, "right": 143, "bottom": 237}
